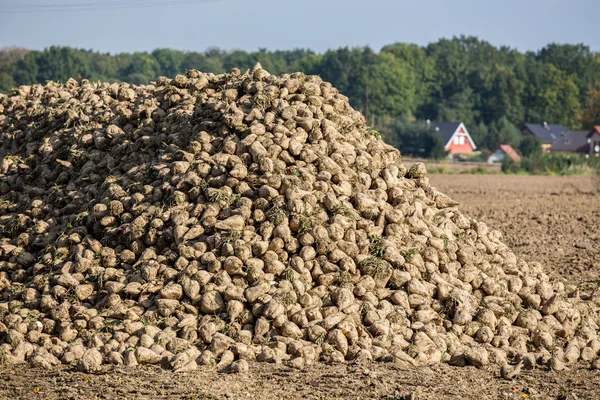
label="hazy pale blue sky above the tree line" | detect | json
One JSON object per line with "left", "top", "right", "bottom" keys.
{"left": 0, "top": 0, "right": 600, "bottom": 53}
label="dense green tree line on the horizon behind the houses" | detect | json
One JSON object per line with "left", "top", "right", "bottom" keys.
{"left": 0, "top": 36, "right": 600, "bottom": 156}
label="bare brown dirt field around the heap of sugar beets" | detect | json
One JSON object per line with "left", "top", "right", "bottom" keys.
{"left": 0, "top": 175, "right": 600, "bottom": 400}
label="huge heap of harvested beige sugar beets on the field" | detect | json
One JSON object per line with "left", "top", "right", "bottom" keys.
{"left": 0, "top": 65, "right": 600, "bottom": 377}
